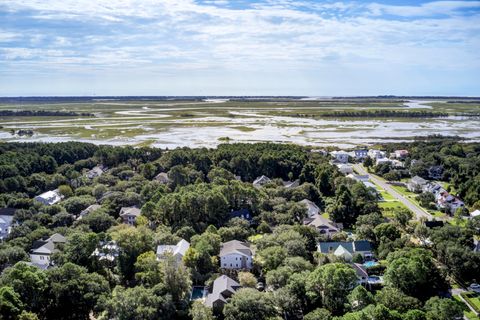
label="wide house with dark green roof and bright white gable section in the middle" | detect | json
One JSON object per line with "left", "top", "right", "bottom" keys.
{"left": 318, "top": 240, "right": 373, "bottom": 261}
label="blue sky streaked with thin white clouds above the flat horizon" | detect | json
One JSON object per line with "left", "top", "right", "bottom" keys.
{"left": 0, "top": 0, "right": 480, "bottom": 96}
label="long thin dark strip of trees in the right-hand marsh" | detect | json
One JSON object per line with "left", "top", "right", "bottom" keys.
{"left": 312, "top": 110, "right": 448, "bottom": 118}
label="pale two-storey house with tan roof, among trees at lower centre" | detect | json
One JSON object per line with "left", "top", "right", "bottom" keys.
{"left": 219, "top": 240, "right": 253, "bottom": 270}
